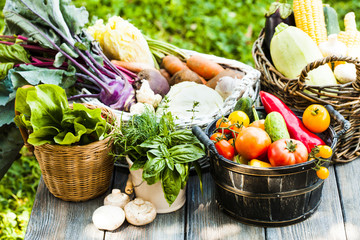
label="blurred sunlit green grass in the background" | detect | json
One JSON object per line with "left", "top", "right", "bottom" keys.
{"left": 0, "top": 0, "right": 360, "bottom": 239}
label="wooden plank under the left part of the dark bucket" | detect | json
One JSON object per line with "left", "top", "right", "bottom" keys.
{"left": 186, "top": 172, "right": 265, "bottom": 240}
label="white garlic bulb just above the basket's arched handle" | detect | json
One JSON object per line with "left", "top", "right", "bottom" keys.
{"left": 319, "top": 34, "right": 347, "bottom": 57}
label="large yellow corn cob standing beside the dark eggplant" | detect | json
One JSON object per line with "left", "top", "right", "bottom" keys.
{"left": 293, "top": 0, "right": 327, "bottom": 45}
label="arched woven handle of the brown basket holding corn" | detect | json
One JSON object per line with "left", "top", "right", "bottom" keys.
{"left": 299, "top": 55, "right": 360, "bottom": 86}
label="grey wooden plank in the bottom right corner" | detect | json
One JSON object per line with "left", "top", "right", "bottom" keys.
{"left": 335, "top": 159, "right": 360, "bottom": 240}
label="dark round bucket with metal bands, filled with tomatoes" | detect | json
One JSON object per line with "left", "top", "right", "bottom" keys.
{"left": 193, "top": 108, "right": 348, "bottom": 227}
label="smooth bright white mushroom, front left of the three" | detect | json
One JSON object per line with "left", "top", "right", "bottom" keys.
{"left": 92, "top": 205, "right": 125, "bottom": 231}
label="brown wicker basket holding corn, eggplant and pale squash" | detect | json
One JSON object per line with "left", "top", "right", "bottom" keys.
{"left": 252, "top": 32, "right": 360, "bottom": 163}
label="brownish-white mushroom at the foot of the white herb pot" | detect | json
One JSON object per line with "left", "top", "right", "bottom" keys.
{"left": 124, "top": 198, "right": 156, "bottom": 226}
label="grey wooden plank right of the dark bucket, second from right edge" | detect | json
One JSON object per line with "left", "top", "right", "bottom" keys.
{"left": 266, "top": 166, "right": 346, "bottom": 240}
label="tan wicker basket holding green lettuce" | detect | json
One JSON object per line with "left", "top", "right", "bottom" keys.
{"left": 16, "top": 104, "right": 116, "bottom": 202}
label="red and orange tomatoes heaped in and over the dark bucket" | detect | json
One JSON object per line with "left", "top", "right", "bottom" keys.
{"left": 210, "top": 105, "right": 332, "bottom": 179}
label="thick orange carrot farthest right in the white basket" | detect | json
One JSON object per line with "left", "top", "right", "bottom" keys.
{"left": 186, "top": 55, "right": 224, "bottom": 79}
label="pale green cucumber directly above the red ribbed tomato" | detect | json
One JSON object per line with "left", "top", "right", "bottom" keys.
{"left": 265, "top": 112, "right": 290, "bottom": 142}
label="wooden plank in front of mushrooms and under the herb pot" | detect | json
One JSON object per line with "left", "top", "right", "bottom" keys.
{"left": 105, "top": 169, "right": 186, "bottom": 240}
